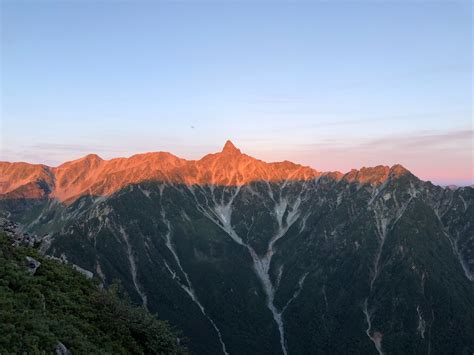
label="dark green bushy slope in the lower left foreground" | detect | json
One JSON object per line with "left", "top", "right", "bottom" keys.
{"left": 0, "top": 233, "right": 186, "bottom": 354}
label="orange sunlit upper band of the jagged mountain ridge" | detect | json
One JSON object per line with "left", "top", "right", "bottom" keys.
{"left": 0, "top": 141, "right": 407, "bottom": 203}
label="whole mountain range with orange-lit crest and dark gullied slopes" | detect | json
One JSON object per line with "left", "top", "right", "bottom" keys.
{"left": 0, "top": 142, "right": 474, "bottom": 354}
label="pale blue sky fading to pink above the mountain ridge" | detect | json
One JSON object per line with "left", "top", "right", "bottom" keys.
{"left": 0, "top": 0, "right": 474, "bottom": 185}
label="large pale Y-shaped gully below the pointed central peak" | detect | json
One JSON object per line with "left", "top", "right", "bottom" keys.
{"left": 188, "top": 182, "right": 307, "bottom": 355}
